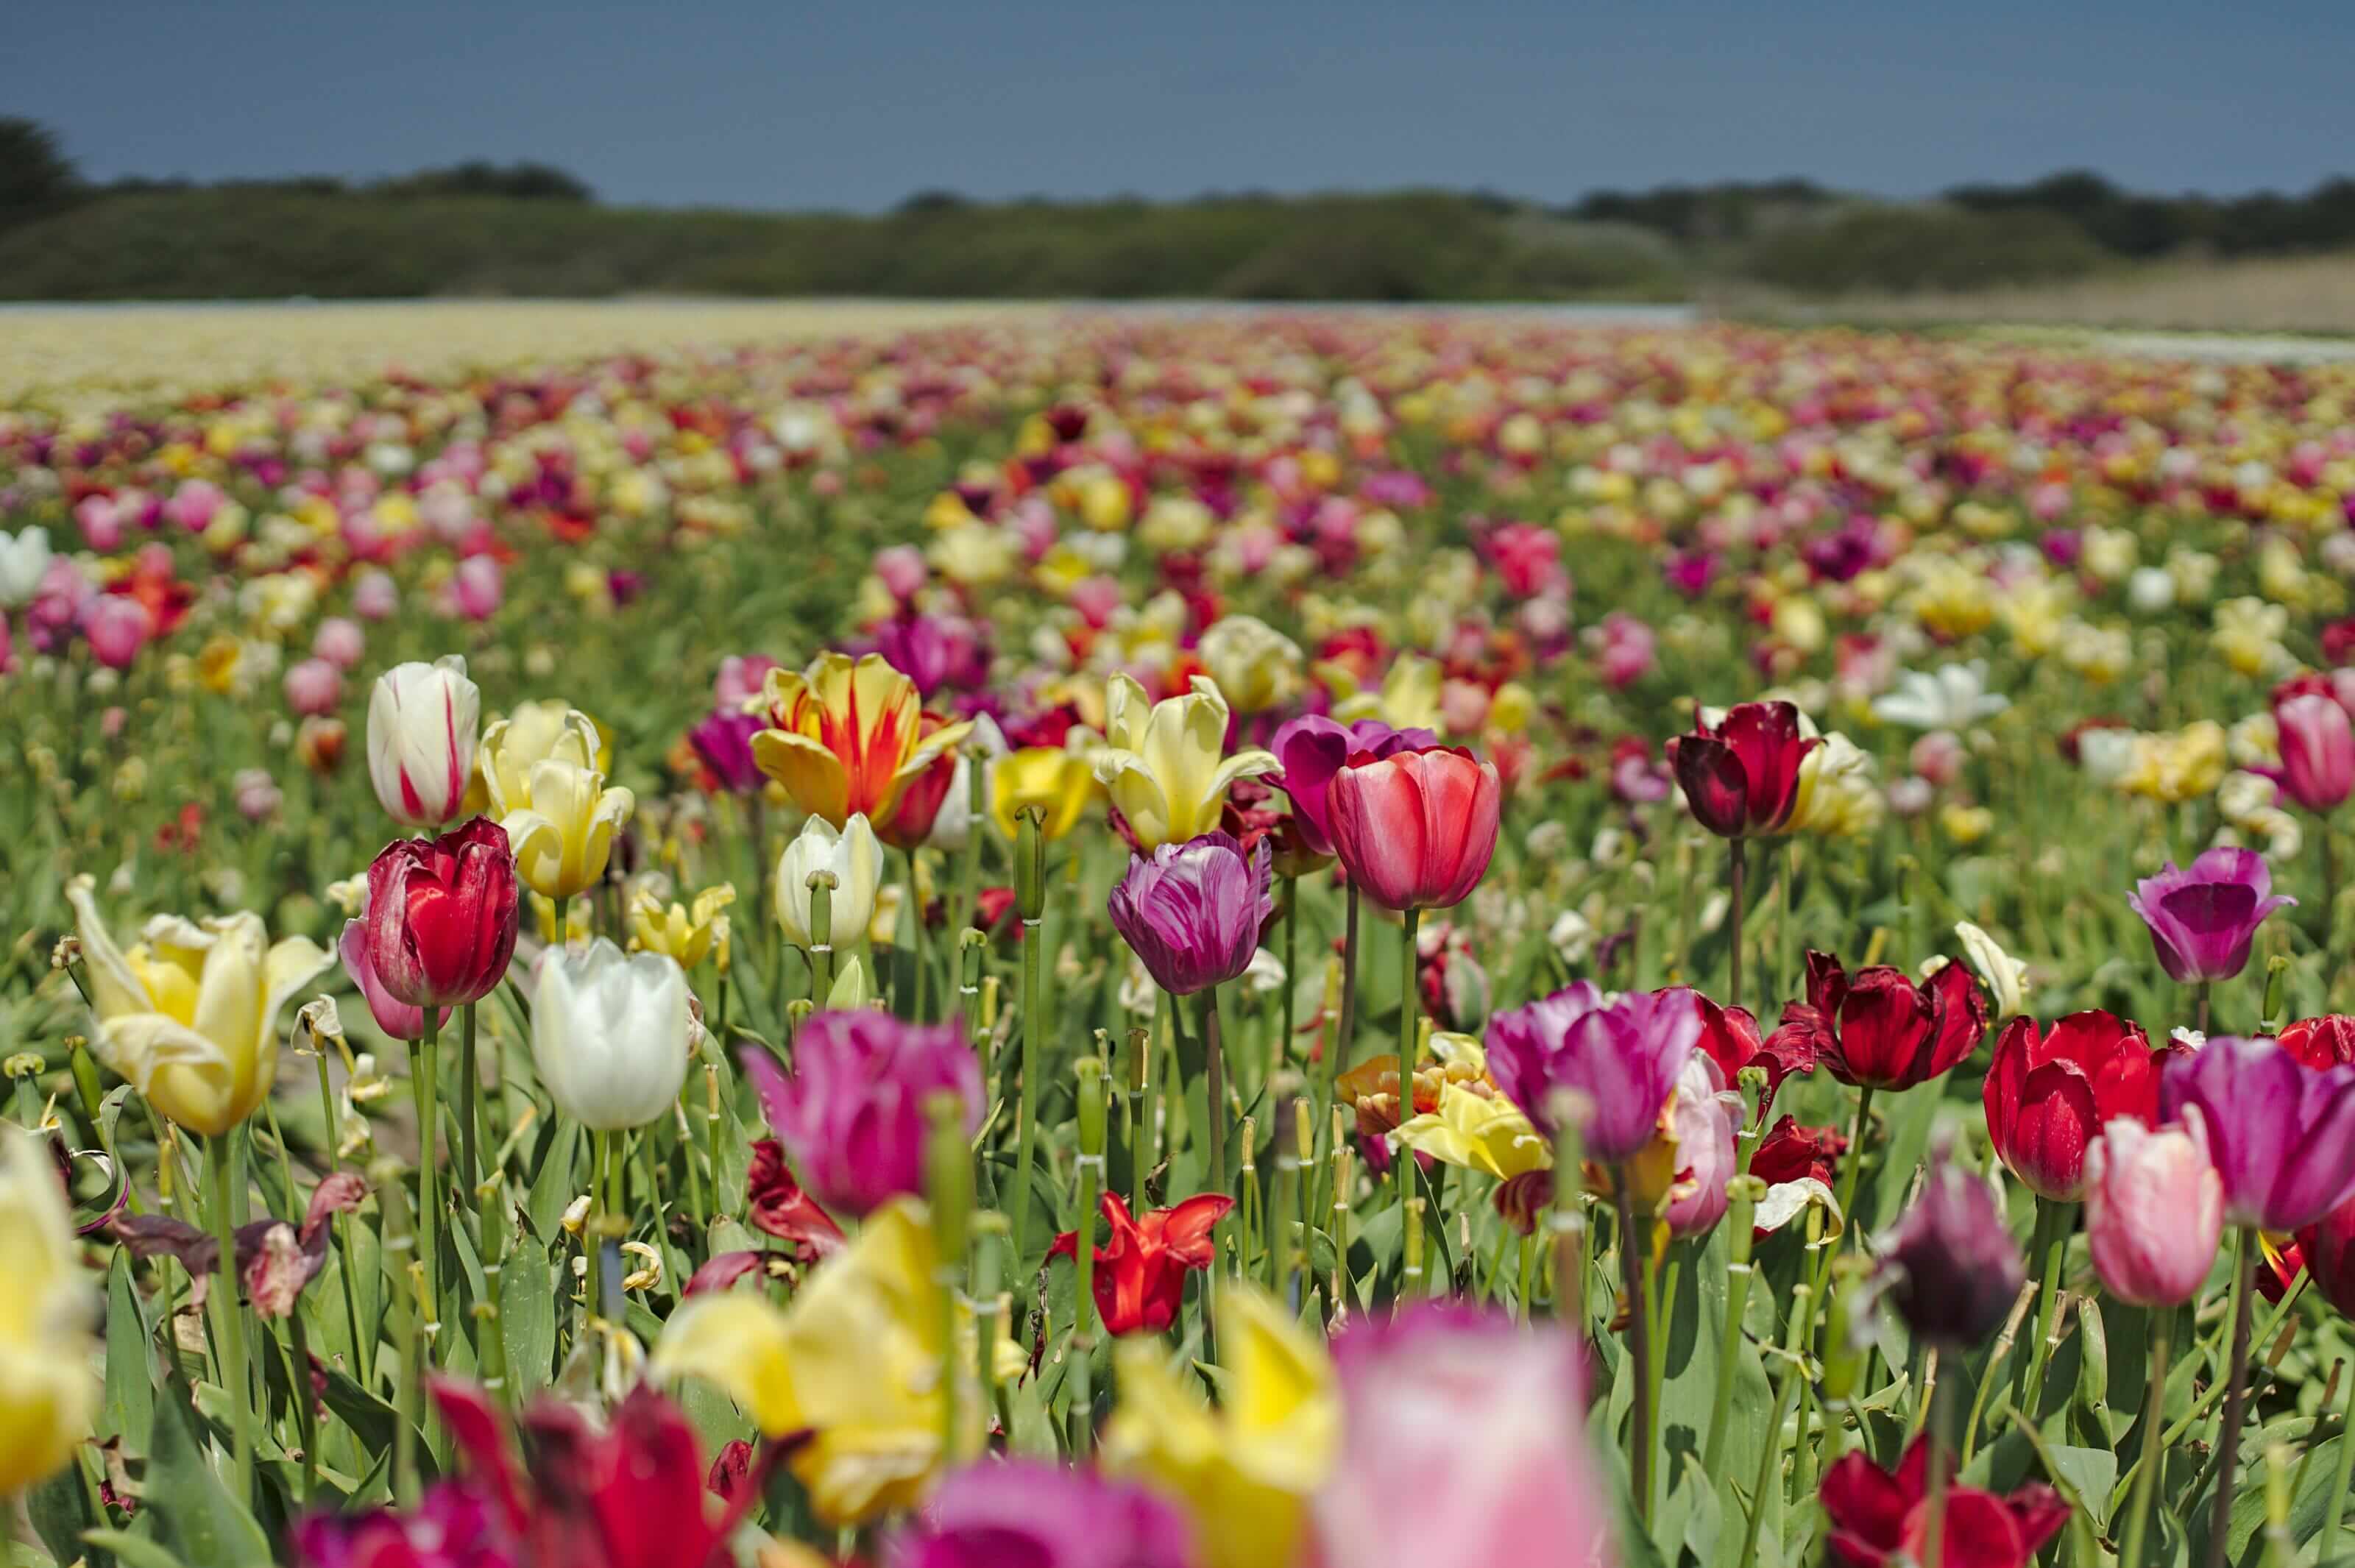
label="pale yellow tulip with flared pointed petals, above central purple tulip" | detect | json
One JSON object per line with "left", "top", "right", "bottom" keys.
{"left": 1095, "top": 675, "right": 1279, "bottom": 850}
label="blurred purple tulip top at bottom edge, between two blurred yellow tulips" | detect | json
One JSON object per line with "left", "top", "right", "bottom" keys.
{"left": 883, "top": 1460, "right": 1199, "bottom": 1568}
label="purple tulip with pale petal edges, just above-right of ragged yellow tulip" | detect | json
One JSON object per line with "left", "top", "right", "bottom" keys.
{"left": 1488, "top": 979, "right": 1700, "bottom": 1166}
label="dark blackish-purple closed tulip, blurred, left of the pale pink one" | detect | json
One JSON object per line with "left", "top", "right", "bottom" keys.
{"left": 1880, "top": 1152, "right": 2028, "bottom": 1352}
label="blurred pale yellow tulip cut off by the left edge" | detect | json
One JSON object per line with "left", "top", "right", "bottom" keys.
{"left": 0, "top": 1123, "right": 96, "bottom": 1500}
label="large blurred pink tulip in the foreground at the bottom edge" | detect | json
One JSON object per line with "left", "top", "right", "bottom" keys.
{"left": 1311, "top": 1302, "right": 1613, "bottom": 1568}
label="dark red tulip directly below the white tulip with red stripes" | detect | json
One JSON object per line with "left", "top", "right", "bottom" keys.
{"left": 367, "top": 817, "right": 516, "bottom": 1007}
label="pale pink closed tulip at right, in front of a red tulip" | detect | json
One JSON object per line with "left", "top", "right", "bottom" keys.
{"left": 2084, "top": 1107, "right": 2223, "bottom": 1307}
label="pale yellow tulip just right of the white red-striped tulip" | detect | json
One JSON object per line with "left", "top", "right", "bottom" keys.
{"left": 483, "top": 709, "right": 638, "bottom": 899}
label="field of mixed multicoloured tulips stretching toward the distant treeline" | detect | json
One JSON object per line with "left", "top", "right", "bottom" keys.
{"left": 18, "top": 311, "right": 2355, "bottom": 1568}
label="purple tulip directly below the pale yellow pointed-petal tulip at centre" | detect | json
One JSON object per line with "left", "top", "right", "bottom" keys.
{"left": 1109, "top": 831, "right": 1276, "bottom": 996}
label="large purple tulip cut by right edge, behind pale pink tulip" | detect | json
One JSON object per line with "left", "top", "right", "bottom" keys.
{"left": 2159, "top": 1038, "right": 2355, "bottom": 1231}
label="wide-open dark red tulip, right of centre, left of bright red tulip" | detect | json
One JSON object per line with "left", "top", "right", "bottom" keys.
{"left": 1766, "top": 951, "right": 1988, "bottom": 1090}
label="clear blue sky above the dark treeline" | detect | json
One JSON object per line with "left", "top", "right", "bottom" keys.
{"left": 18, "top": 0, "right": 2355, "bottom": 210}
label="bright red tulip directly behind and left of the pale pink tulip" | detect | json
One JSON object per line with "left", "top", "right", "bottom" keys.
{"left": 1980, "top": 1010, "right": 2167, "bottom": 1203}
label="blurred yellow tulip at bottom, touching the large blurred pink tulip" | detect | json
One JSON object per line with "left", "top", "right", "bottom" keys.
{"left": 1105, "top": 1285, "right": 1340, "bottom": 1568}
